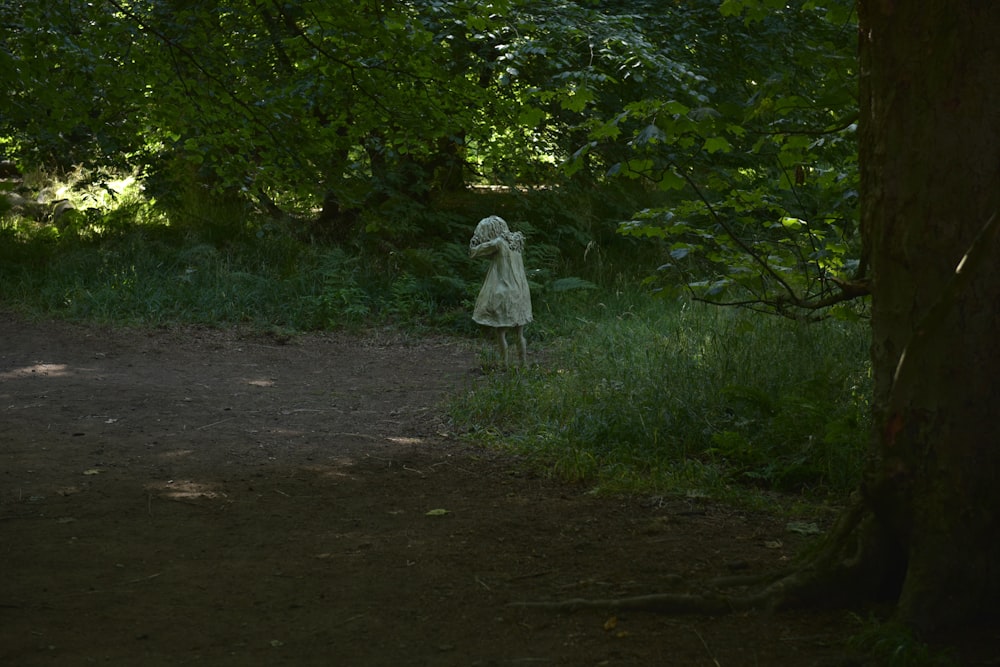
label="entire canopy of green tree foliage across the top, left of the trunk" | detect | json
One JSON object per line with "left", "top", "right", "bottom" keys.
{"left": 0, "top": 0, "right": 864, "bottom": 312}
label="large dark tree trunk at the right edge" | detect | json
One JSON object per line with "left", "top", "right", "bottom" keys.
{"left": 859, "top": 0, "right": 1000, "bottom": 629}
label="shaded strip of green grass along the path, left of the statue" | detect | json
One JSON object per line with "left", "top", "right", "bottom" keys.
{"left": 0, "top": 215, "right": 469, "bottom": 330}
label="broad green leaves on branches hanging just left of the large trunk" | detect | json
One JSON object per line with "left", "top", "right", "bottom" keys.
{"left": 602, "top": 2, "right": 867, "bottom": 316}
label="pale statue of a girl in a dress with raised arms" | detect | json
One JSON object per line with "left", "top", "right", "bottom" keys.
{"left": 469, "top": 215, "right": 531, "bottom": 365}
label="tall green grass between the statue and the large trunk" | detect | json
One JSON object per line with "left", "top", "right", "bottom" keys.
{"left": 450, "top": 293, "right": 869, "bottom": 494}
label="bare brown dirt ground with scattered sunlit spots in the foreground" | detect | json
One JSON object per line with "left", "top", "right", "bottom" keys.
{"left": 0, "top": 313, "right": 997, "bottom": 667}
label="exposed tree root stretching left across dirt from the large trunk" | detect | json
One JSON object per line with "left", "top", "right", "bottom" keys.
{"left": 511, "top": 500, "right": 900, "bottom": 616}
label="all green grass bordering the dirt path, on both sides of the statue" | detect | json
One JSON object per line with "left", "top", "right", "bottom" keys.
{"left": 0, "top": 180, "right": 870, "bottom": 504}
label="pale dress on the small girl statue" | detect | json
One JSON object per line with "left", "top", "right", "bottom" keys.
{"left": 469, "top": 236, "right": 531, "bottom": 327}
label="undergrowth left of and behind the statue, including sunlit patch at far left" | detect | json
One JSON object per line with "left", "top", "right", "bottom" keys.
{"left": 0, "top": 173, "right": 608, "bottom": 335}
